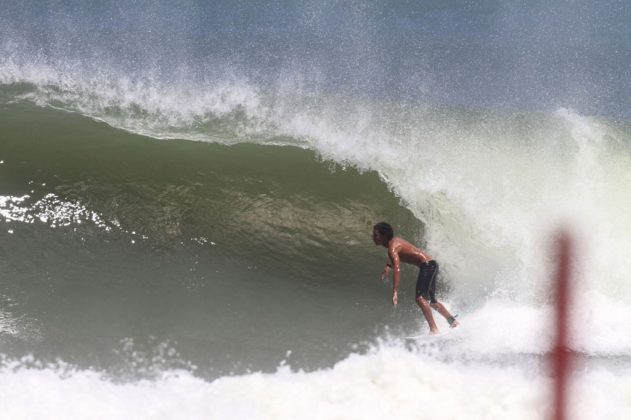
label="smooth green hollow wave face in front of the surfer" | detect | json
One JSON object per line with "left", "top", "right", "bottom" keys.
{"left": 0, "top": 104, "right": 430, "bottom": 375}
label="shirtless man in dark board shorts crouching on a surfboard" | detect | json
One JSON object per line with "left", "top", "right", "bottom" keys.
{"left": 372, "top": 222, "right": 458, "bottom": 334}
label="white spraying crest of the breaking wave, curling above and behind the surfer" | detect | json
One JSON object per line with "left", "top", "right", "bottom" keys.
{"left": 3, "top": 74, "right": 630, "bottom": 306}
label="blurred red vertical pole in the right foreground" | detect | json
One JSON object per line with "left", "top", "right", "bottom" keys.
{"left": 553, "top": 231, "right": 572, "bottom": 420}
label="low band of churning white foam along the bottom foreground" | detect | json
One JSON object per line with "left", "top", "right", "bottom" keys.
{"left": 0, "top": 346, "right": 631, "bottom": 420}
